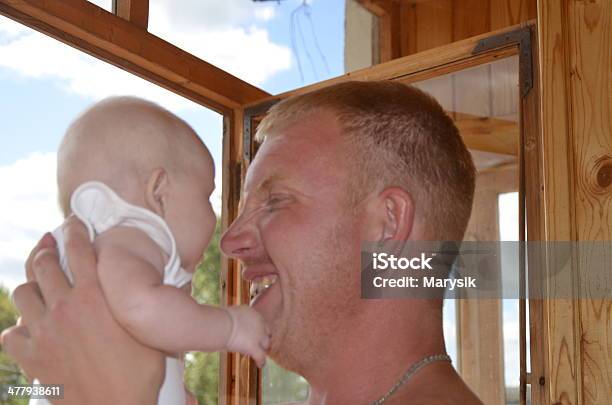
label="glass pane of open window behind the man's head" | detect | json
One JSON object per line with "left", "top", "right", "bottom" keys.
{"left": 399, "top": 56, "right": 520, "bottom": 404}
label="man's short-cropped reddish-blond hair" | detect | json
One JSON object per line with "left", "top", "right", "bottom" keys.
{"left": 256, "top": 81, "right": 475, "bottom": 240}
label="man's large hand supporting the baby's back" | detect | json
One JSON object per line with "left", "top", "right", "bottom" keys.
{"left": 0, "top": 217, "right": 164, "bottom": 405}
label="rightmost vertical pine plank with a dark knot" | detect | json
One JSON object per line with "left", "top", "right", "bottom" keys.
{"left": 566, "top": 0, "right": 612, "bottom": 405}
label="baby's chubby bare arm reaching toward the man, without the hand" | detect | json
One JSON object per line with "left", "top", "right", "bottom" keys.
{"left": 95, "top": 227, "right": 232, "bottom": 353}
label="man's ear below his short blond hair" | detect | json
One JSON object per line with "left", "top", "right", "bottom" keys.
{"left": 370, "top": 187, "right": 414, "bottom": 242}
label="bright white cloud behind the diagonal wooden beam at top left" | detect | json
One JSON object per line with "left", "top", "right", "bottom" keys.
{"left": 0, "top": 0, "right": 291, "bottom": 112}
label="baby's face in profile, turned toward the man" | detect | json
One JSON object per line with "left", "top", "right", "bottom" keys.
{"left": 164, "top": 158, "right": 217, "bottom": 272}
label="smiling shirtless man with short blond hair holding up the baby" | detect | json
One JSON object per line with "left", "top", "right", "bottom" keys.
{"left": 3, "top": 82, "right": 480, "bottom": 405}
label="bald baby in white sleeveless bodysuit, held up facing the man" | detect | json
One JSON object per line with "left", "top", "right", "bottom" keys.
{"left": 30, "top": 97, "right": 269, "bottom": 405}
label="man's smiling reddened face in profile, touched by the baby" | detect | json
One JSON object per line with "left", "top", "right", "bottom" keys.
{"left": 221, "top": 109, "right": 360, "bottom": 370}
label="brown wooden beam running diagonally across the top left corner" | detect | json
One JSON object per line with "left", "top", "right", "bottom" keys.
{"left": 0, "top": 0, "right": 269, "bottom": 114}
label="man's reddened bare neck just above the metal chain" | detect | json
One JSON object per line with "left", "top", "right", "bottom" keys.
{"left": 304, "top": 305, "right": 445, "bottom": 405}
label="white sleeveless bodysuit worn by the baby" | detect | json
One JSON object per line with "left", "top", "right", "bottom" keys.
{"left": 30, "top": 181, "right": 192, "bottom": 405}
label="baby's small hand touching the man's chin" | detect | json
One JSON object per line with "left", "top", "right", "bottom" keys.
{"left": 225, "top": 305, "right": 270, "bottom": 367}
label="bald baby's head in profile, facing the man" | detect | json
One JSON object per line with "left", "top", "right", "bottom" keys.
{"left": 57, "top": 97, "right": 216, "bottom": 271}
